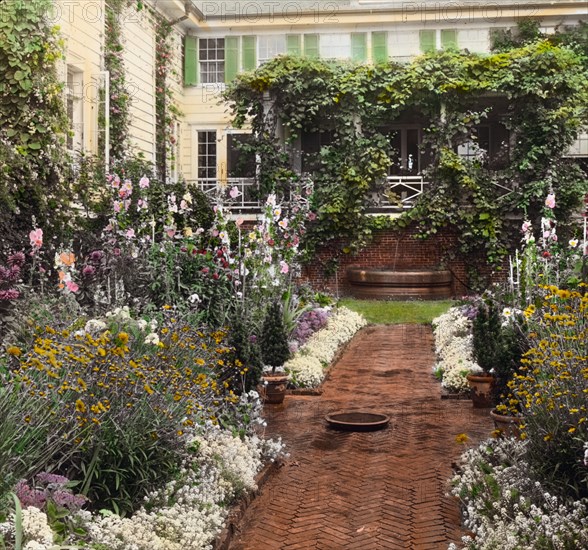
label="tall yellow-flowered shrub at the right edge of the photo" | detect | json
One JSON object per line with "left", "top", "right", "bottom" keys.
{"left": 501, "top": 284, "right": 588, "bottom": 495}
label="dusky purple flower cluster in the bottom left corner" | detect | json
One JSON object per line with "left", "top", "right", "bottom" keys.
{"left": 14, "top": 472, "right": 88, "bottom": 512}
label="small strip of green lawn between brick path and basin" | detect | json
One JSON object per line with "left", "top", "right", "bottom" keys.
{"left": 339, "top": 298, "right": 453, "bottom": 325}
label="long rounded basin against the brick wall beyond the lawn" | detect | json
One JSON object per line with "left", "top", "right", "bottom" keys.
{"left": 347, "top": 267, "right": 453, "bottom": 300}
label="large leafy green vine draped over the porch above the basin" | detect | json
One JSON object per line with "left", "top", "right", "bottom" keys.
{"left": 226, "top": 31, "right": 588, "bottom": 270}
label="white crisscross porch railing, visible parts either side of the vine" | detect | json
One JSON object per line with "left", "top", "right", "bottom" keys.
{"left": 189, "top": 176, "right": 429, "bottom": 214}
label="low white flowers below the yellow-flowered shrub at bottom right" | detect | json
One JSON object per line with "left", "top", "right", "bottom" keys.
{"left": 448, "top": 438, "right": 588, "bottom": 550}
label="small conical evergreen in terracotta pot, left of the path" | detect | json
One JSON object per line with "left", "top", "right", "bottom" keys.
{"left": 260, "top": 301, "right": 290, "bottom": 404}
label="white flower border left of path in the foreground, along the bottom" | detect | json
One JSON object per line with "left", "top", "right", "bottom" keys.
{"left": 0, "top": 391, "right": 283, "bottom": 550}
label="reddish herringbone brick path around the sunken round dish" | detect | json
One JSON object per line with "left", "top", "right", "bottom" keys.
{"left": 230, "top": 325, "right": 492, "bottom": 550}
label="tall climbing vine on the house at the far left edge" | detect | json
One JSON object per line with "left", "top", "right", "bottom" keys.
{"left": 0, "top": 0, "right": 68, "bottom": 242}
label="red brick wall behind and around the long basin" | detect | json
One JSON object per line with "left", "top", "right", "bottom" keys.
{"left": 302, "top": 229, "right": 505, "bottom": 297}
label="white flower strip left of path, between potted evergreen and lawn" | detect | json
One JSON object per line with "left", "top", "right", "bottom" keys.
{"left": 284, "top": 307, "right": 367, "bottom": 388}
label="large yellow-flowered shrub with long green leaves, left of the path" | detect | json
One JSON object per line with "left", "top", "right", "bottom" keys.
{"left": 0, "top": 318, "right": 240, "bottom": 512}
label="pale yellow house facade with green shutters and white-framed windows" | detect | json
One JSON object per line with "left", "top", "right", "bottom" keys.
{"left": 52, "top": 0, "right": 588, "bottom": 183}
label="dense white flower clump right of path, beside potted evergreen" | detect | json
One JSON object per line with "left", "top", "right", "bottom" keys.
{"left": 433, "top": 306, "right": 482, "bottom": 393}
